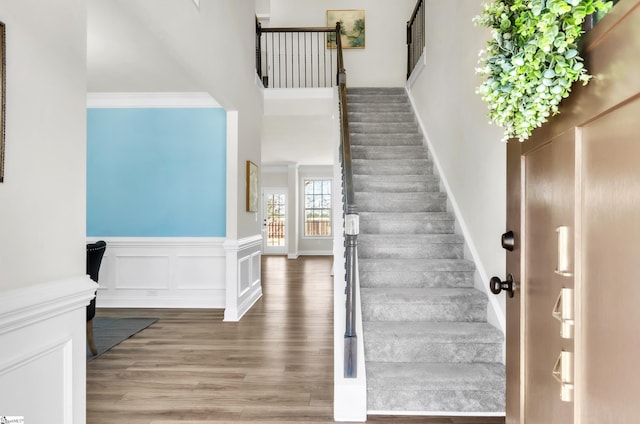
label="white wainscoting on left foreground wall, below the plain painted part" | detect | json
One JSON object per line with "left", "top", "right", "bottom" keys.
{"left": 0, "top": 276, "right": 96, "bottom": 424}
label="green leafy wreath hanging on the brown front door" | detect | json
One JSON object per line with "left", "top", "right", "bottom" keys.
{"left": 474, "top": 0, "right": 612, "bottom": 141}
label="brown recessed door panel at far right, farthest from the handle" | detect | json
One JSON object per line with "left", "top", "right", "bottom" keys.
{"left": 577, "top": 98, "right": 640, "bottom": 424}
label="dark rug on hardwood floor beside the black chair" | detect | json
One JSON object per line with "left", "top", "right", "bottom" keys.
{"left": 87, "top": 318, "right": 158, "bottom": 361}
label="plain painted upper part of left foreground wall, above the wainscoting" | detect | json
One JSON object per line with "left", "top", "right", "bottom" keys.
{"left": 0, "top": 0, "right": 86, "bottom": 290}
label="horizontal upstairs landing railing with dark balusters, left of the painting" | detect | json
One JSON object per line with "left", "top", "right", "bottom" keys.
{"left": 256, "top": 23, "right": 338, "bottom": 88}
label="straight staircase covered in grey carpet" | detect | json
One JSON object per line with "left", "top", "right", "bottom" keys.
{"left": 348, "top": 88, "right": 505, "bottom": 414}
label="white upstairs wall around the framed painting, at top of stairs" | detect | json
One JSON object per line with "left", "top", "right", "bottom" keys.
{"left": 270, "top": 0, "right": 416, "bottom": 87}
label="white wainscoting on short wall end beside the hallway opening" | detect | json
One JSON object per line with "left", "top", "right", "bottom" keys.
{"left": 224, "top": 234, "right": 262, "bottom": 321}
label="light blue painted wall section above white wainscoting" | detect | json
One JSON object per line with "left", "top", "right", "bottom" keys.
{"left": 87, "top": 108, "right": 226, "bottom": 237}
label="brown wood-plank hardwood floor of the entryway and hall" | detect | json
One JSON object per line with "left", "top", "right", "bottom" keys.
{"left": 87, "top": 256, "right": 504, "bottom": 424}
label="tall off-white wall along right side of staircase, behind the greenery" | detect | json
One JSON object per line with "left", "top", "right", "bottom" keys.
{"left": 409, "top": 0, "right": 506, "bottom": 325}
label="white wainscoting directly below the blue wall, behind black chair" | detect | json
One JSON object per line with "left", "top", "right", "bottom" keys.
{"left": 88, "top": 237, "right": 227, "bottom": 308}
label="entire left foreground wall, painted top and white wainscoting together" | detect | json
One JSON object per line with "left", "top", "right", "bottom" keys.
{"left": 0, "top": 0, "right": 95, "bottom": 424}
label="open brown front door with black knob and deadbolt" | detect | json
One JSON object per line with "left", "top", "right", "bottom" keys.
{"left": 506, "top": 0, "right": 640, "bottom": 424}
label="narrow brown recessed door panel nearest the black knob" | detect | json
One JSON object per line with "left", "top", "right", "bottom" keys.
{"left": 522, "top": 132, "right": 575, "bottom": 424}
